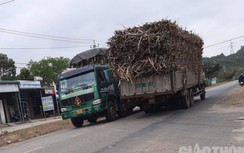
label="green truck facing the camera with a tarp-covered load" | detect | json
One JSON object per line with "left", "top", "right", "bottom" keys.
{"left": 58, "top": 48, "right": 125, "bottom": 127}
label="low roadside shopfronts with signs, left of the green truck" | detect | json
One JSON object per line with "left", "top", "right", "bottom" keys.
{"left": 0, "top": 80, "right": 57, "bottom": 124}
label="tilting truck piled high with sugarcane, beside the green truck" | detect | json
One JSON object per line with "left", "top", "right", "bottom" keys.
{"left": 108, "top": 20, "right": 206, "bottom": 113}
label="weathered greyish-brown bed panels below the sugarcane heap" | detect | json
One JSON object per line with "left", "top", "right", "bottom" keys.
{"left": 120, "top": 71, "right": 201, "bottom": 99}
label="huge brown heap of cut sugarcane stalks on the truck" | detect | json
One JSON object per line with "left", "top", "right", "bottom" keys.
{"left": 108, "top": 20, "right": 203, "bottom": 82}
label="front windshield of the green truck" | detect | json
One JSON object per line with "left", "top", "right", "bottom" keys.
{"left": 59, "top": 72, "right": 96, "bottom": 93}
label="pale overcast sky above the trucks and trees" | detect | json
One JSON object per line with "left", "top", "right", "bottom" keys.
{"left": 0, "top": 0, "right": 244, "bottom": 69}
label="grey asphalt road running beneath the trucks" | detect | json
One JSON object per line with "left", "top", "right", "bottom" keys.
{"left": 0, "top": 82, "right": 244, "bottom": 153}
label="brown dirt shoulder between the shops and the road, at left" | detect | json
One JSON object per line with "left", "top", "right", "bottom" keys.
{"left": 0, "top": 120, "right": 72, "bottom": 147}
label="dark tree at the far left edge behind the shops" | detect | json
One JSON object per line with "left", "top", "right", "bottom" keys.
{"left": 0, "top": 53, "right": 16, "bottom": 80}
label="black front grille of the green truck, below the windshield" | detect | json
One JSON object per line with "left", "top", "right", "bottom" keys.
{"left": 62, "top": 93, "right": 94, "bottom": 106}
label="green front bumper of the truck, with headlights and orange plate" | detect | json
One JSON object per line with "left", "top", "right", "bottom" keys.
{"left": 61, "top": 104, "right": 105, "bottom": 120}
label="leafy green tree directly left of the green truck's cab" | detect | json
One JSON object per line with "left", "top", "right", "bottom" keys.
{"left": 28, "top": 57, "right": 69, "bottom": 86}
